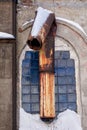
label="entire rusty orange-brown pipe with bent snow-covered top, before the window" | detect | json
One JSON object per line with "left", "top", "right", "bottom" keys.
{"left": 27, "top": 8, "right": 57, "bottom": 118}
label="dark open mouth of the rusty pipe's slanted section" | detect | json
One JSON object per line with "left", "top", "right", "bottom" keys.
{"left": 27, "top": 38, "right": 42, "bottom": 50}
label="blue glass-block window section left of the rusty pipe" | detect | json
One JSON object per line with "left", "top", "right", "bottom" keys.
{"left": 22, "top": 51, "right": 40, "bottom": 113}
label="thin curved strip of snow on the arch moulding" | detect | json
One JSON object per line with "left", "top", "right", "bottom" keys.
{"left": 56, "top": 17, "right": 87, "bottom": 36}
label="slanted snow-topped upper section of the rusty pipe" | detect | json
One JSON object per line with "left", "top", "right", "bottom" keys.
{"left": 27, "top": 7, "right": 56, "bottom": 50}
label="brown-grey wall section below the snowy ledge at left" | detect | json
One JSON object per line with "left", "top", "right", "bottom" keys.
{"left": 0, "top": 39, "right": 15, "bottom": 130}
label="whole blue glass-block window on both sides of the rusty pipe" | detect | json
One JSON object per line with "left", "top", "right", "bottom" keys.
{"left": 21, "top": 51, "right": 77, "bottom": 114}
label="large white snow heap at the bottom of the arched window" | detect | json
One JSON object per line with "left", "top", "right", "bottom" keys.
{"left": 19, "top": 108, "right": 82, "bottom": 130}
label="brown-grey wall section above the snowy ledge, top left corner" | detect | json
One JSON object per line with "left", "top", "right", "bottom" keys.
{"left": 0, "top": 0, "right": 13, "bottom": 34}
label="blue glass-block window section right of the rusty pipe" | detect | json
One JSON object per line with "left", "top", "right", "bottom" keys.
{"left": 55, "top": 51, "right": 77, "bottom": 113}
